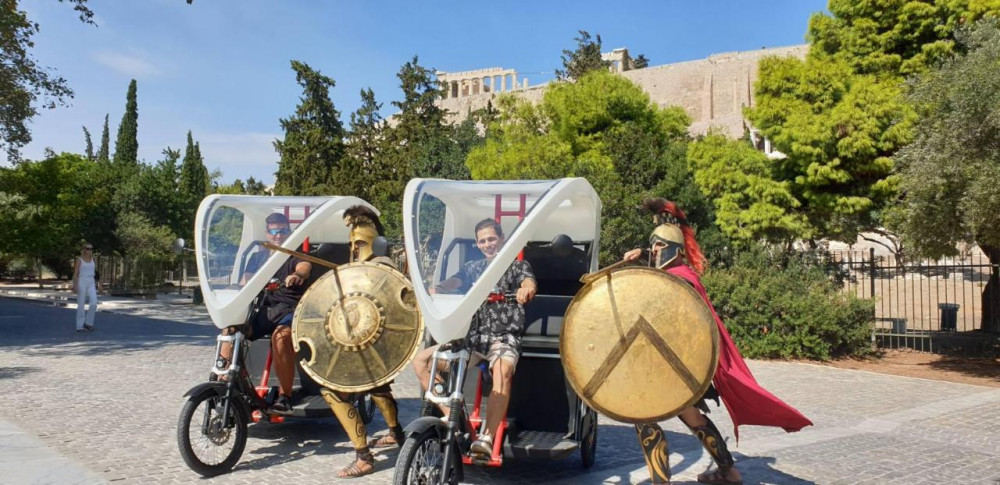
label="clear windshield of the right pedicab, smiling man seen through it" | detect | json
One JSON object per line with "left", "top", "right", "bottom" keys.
{"left": 411, "top": 180, "right": 556, "bottom": 295}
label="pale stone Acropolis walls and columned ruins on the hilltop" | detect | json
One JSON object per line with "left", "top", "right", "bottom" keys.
{"left": 437, "top": 45, "right": 808, "bottom": 138}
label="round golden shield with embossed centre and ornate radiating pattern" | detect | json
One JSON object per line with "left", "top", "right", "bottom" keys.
{"left": 292, "top": 262, "right": 424, "bottom": 392}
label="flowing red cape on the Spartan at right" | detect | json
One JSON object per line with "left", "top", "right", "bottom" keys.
{"left": 667, "top": 265, "right": 812, "bottom": 442}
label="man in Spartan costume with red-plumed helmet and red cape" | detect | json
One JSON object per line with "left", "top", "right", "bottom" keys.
{"left": 622, "top": 198, "right": 812, "bottom": 484}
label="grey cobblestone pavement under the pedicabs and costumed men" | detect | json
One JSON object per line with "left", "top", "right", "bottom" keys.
{"left": 0, "top": 298, "right": 1000, "bottom": 484}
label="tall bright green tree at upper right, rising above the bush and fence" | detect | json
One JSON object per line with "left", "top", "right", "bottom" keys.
{"left": 746, "top": 0, "right": 1000, "bottom": 246}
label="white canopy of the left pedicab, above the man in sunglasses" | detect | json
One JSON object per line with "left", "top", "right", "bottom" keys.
{"left": 195, "top": 195, "right": 378, "bottom": 328}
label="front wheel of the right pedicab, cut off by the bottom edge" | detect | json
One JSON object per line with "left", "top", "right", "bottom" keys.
{"left": 392, "top": 428, "right": 462, "bottom": 485}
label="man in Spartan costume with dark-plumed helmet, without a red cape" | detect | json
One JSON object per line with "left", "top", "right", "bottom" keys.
{"left": 320, "top": 205, "right": 403, "bottom": 478}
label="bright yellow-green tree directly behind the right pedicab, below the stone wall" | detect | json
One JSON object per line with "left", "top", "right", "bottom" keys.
{"left": 466, "top": 70, "right": 713, "bottom": 264}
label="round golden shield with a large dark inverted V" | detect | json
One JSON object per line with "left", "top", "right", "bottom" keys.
{"left": 559, "top": 267, "right": 719, "bottom": 423}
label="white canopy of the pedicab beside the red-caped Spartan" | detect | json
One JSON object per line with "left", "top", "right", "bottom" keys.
{"left": 403, "top": 178, "right": 601, "bottom": 342}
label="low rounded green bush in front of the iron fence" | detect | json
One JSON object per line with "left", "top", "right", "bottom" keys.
{"left": 704, "top": 246, "right": 875, "bottom": 360}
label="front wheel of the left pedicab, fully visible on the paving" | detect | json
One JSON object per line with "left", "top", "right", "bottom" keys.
{"left": 177, "top": 391, "right": 247, "bottom": 477}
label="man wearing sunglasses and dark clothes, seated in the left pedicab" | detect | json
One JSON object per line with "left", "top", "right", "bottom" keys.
{"left": 222, "top": 212, "right": 312, "bottom": 413}
